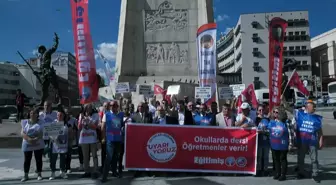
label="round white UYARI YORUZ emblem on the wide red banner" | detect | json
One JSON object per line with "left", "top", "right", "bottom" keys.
{"left": 147, "top": 133, "right": 177, "bottom": 163}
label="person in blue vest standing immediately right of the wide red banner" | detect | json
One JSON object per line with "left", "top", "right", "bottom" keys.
{"left": 256, "top": 105, "right": 270, "bottom": 177}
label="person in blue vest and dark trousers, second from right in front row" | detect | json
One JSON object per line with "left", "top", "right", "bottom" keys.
{"left": 267, "top": 107, "right": 293, "bottom": 181}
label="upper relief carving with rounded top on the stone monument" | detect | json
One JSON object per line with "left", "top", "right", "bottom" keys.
{"left": 145, "top": 1, "right": 188, "bottom": 31}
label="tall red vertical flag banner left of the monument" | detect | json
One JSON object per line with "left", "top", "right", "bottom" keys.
{"left": 70, "top": 0, "right": 99, "bottom": 104}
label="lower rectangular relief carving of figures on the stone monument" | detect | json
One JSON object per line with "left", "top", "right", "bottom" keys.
{"left": 146, "top": 42, "right": 188, "bottom": 64}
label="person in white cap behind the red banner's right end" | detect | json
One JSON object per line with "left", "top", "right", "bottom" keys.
{"left": 235, "top": 102, "right": 255, "bottom": 128}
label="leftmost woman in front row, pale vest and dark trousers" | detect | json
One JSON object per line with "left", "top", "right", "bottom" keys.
{"left": 21, "top": 108, "right": 44, "bottom": 182}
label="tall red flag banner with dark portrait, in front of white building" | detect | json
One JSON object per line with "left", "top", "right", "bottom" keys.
{"left": 268, "top": 17, "right": 287, "bottom": 110}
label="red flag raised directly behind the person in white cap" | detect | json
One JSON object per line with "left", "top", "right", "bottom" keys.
{"left": 237, "top": 84, "right": 258, "bottom": 112}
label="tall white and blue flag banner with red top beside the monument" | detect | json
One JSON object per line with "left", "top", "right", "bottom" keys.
{"left": 196, "top": 23, "right": 217, "bottom": 105}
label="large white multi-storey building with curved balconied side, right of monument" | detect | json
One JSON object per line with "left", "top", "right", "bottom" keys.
{"left": 217, "top": 11, "right": 311, "bottom": 90}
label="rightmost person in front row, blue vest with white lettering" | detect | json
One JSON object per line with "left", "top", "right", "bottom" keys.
{"left": 295, "top": 100, "right": 323, "bottom": 183}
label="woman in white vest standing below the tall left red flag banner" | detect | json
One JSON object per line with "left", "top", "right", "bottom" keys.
{"left": 78, "top": 104, "right": 99, "bottom": 178}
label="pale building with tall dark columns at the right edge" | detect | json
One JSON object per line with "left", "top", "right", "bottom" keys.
{"left": 311, "top": 28, "right": 336, "bottom": 91}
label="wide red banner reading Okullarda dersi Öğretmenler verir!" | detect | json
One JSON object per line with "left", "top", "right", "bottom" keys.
{"left": 125, "top": 124, "right": 257, "bottom": 174}
